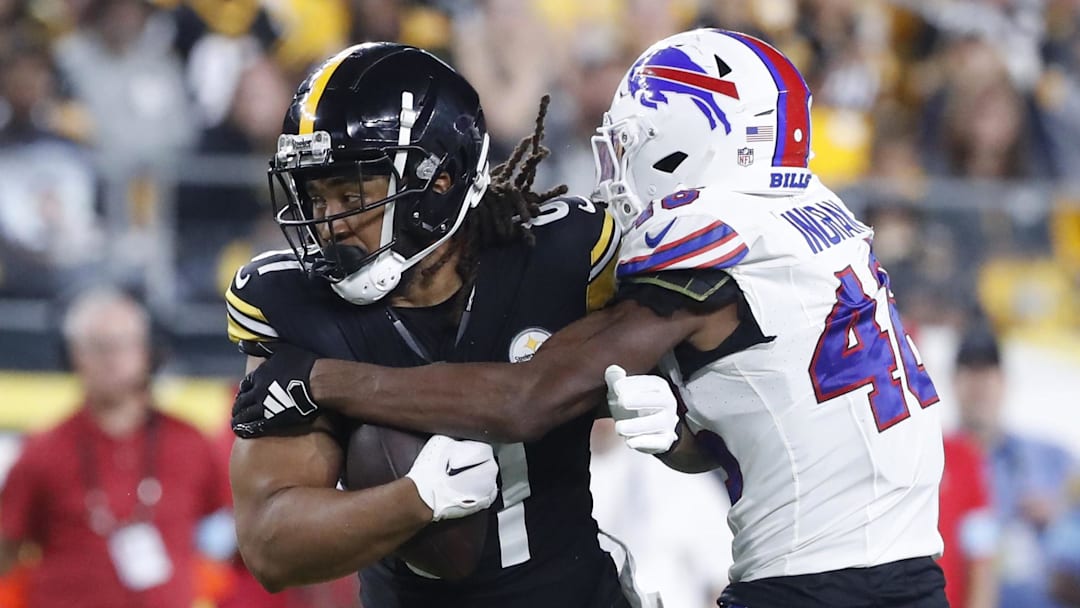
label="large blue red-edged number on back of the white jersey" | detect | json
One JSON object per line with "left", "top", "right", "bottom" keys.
{"left": 810, "top": 256, "right": 939, "bottom": 432}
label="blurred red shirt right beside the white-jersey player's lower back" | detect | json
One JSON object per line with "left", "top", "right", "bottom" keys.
{"left": 937, "top": 435, "right": 997, "bottom": 608}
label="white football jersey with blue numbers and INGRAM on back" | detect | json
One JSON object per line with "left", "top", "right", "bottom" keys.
{"left": 619, "top": 178, "right": 944, "bottom": 581}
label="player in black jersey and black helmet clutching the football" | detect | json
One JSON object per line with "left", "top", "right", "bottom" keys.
{"left": 226, "top": 43, "right": 629, "bottom": 608}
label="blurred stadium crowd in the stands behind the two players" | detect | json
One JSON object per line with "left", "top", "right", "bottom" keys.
{"left": 0, "top": 0, "right": 1080, "bottom": 606}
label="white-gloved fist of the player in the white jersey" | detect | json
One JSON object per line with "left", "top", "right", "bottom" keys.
{"left": 604, "top": 365, "right": 678, "bottom": 454}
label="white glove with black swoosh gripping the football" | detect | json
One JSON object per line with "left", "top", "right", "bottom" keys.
{"left": 405, "top": 435, "right": 499, "bottom": 522}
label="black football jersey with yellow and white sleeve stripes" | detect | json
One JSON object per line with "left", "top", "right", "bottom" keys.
{"left": 226, "top": 197, "right": 621, "bottom": 608}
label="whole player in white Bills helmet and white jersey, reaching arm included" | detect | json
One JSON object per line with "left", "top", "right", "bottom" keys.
{"left": 233, "top": 29, "right": 947, "bottom": 608}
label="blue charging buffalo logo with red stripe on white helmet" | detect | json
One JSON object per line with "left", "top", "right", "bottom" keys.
{"left": 627, "top": 46, "right": 739, "bottom": 133}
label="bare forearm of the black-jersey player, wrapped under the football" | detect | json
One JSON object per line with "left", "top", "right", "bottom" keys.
{"left": 237, "top": 478, "right": 431, "bottom": 592}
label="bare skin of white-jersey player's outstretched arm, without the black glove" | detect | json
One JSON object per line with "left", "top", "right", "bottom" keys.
{"left": 311, "top": 300, "right": 717, "bottom": 442}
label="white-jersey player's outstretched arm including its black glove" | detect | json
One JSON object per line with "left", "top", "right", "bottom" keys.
{"left": 232, "top": 300, "right": 739, "bottom": 443}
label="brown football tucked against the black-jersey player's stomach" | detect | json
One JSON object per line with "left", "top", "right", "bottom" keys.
{"left": 345, "top": 424, "right": 488, "bottom": 580}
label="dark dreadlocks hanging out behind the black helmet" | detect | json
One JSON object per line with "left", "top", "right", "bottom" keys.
{"left": 440, "top": 95, "right": 567, "bottom": 292}
